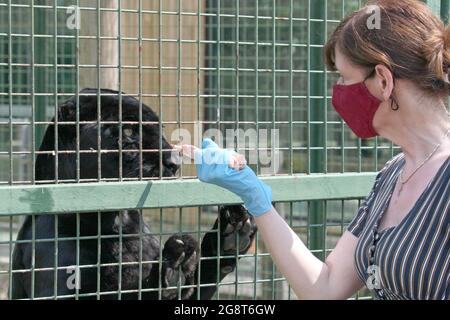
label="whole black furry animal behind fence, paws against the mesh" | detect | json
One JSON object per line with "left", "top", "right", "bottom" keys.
{"left": 11, "top": 89, "right": 256, "bottom": 299}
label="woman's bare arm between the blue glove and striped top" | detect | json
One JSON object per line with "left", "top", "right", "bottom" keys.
{"left": 255, "top": 207, "right": 364, "bottom": 299}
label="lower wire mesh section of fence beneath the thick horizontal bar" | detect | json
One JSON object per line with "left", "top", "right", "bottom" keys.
{"left": 0, "top": 200, "right": 370, "bottom": 300}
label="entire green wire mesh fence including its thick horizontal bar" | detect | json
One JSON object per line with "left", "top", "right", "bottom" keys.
{"left": 0, "top": 0, "right": 448, "bottom": 299}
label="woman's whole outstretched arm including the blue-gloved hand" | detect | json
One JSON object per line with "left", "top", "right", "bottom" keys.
{"left": 181, "top": 139, "right": 363, "bottom": 299}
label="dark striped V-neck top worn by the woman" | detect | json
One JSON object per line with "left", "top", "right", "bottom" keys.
{"left": 347, "top": 154, "right": 450, "bottom": 300}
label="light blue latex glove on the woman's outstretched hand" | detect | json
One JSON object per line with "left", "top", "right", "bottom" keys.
{"left": 194, "top": 139, "right": 272, "bottom": 216}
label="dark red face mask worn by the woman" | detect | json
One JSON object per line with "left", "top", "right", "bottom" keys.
{"left": 332, "top": 80, "right": 381, "bottom": 139}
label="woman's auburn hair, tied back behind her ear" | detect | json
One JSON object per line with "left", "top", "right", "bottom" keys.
{"left": 324, "top": 0, "right": 450, "bottom": 96}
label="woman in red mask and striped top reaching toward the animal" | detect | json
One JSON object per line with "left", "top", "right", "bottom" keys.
{"left": 181, "top": 0, "right": 450, "bottom": 299}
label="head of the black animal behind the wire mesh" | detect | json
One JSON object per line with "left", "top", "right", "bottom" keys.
{"left": 36, "top": 89, "right": 179, "bottom": 180}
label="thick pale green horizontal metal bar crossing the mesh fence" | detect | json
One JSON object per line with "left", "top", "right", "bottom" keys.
{"left": 0, "top": 173, "right": 375, "bottom": 216}
